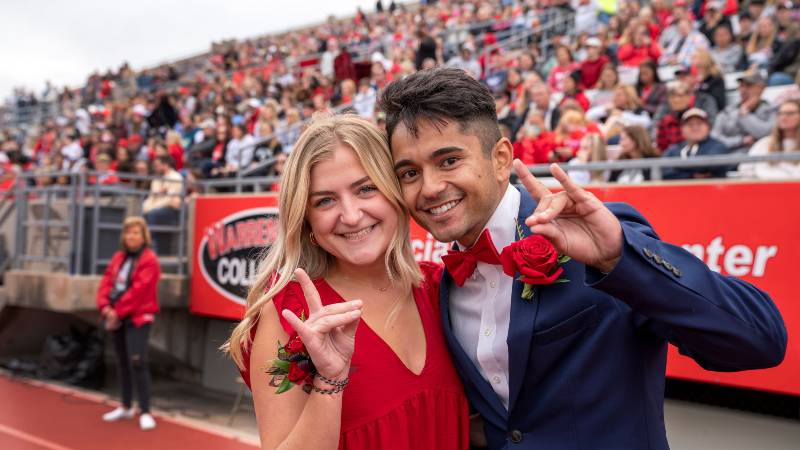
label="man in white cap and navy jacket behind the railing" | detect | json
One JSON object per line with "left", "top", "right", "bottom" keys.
{"left": 662, "top": 108, "right": 730, "bottom": 180}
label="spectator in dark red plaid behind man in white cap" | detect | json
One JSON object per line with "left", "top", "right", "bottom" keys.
{"left": 656, "top": 80, "right": 717, "bottom": 152}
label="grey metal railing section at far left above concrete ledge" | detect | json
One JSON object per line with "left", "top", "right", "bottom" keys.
{"left": 7, "top": 171, "right": 188, "bottom": 275}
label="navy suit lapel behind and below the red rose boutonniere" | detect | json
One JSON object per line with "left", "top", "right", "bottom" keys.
{"left": 506, "top": 189, "right": 541, "bottom": 411}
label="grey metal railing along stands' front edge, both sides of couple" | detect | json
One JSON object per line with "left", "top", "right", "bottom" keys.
{"left": 0, "top": 152, "right": 800, "bottom": 275}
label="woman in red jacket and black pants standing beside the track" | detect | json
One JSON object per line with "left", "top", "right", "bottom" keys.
{"left": 97, "top": 217, "right": 161, "bottom": 430}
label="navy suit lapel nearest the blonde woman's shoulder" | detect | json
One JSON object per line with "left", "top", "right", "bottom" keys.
{"left": 439, "top": 268, "right": 506, "bottom": 428}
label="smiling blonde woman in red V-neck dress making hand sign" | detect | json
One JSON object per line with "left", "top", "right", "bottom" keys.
{"left": 226, "top": 115, "right": 469, "bottom": 450}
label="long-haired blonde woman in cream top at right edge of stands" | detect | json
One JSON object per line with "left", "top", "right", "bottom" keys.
{"left": 739, "top": 99, "right": 800, "bottom": 180}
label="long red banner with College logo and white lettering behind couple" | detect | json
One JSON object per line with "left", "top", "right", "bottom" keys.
{"left": 191, "top": 183, "right": 800, "bottom": 395}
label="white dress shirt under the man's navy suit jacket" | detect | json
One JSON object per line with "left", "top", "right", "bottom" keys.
{"left": 450, "top": 185, "right": 520, "bottom": 409}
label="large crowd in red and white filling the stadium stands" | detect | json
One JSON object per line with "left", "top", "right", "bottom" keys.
{"left": 0, "top": 0, "right": 800, "bottom": 207}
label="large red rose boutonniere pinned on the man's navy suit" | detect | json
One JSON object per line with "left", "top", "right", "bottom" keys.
{"left": 500, "top": 225, "right": 570, "bottom": 300}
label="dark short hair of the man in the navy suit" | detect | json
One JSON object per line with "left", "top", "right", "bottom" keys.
{"left": 379, "top": 68, "right": 502, "bottom": 155}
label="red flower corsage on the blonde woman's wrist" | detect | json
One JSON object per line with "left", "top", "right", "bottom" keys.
{"left": 267, "top": 314, "right": 317, "bottom": 394}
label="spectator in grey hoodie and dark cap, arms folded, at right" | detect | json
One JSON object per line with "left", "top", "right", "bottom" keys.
{"left": 712, "top": 71, "right": 775, "bottom": 152}
